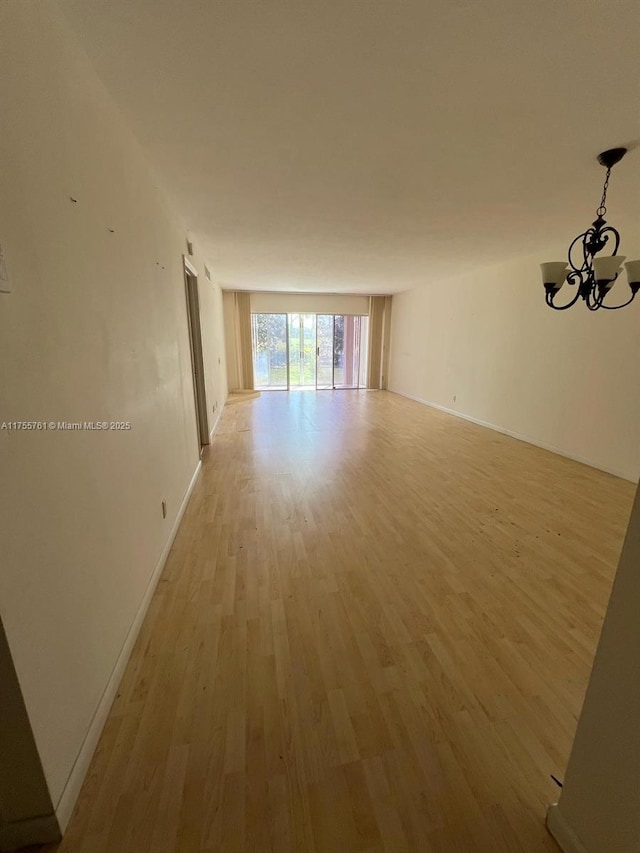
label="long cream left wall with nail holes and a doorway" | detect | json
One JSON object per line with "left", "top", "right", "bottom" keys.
{"left": 0, "top": 0, "right": 226, "bottom": 814}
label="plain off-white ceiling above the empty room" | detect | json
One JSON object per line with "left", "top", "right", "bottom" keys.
{"left": 59, "top": 0, "right": 640, "bottom": 293}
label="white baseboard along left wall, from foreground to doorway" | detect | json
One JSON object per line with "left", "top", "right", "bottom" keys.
{"left": 55, "top": 462, "right": 202, "bottom": 832}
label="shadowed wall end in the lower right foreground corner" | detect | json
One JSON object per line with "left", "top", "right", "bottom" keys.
{"left": 547, "top": 482, "right": 640, "bottom": 853}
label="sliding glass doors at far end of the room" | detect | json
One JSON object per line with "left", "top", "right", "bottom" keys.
{"left": 251, "top": 313, "right": 369, "bottom": 391}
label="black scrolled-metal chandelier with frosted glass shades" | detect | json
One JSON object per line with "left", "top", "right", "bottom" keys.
{"left": 540, "top": 148, "right": 640, "bottom": 311}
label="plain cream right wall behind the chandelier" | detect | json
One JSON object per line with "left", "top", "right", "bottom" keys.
{"left": 389, "top": 233, "right": 640, "bottom": 480}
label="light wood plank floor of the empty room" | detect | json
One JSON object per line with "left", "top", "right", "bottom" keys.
{"left": 47, "top": 391, "right": 634, "bottom": 853}
